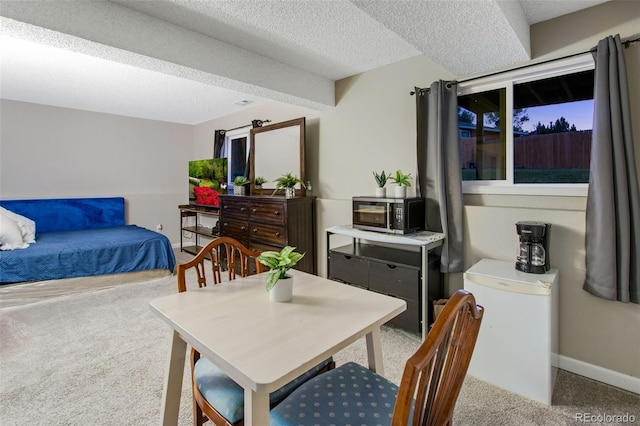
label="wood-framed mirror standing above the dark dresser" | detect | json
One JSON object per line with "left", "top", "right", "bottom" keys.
{"left": 249, "top": 117, "right": 306, "bottom": 195}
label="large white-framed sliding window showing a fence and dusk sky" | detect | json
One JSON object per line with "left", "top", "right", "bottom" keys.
{"left": 458, "top": 55, "right": 594, "bottom": 195}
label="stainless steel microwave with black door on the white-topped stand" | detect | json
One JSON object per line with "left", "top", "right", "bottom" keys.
{"left": 353, "top": 197, "right": 425, "bottom": 234}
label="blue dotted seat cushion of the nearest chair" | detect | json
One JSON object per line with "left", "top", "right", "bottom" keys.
{"left": 270, "top": 362, "right": 398, "bottom": 426}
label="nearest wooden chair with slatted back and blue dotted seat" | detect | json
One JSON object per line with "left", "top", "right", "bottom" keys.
{"left": 270, "top": 290, "right": 484, "bottom": 426}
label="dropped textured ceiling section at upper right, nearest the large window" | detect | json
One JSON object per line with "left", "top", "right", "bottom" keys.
{"left": 351, "top": 0, "right": 531, "bottom": 76}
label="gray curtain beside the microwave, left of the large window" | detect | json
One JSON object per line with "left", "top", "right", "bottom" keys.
{"left": 415, "top": 80, "right": 464, "bottom": 272}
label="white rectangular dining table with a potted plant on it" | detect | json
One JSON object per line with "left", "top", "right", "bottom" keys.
{"left": 150, "top": 270, "right": 407, "bottom": 426}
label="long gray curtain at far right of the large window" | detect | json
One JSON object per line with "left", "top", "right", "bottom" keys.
{"left": 583, "top": 35, "right": 640, "bottom": 303}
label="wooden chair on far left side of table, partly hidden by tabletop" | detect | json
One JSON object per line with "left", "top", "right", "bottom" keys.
{"left": 176, "top": 237, "right": 335, "bottom": 426}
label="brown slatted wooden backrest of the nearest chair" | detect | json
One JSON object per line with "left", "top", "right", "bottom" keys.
{"left": 392, "top": 290, "right": 484, "bottom": 426}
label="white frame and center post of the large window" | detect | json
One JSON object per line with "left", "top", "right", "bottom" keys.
{"left": 457, "top": 53, "right": 595, "bottom": 197}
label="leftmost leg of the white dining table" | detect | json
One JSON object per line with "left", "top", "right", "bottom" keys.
{"left": 161, "top": 331, "right": 187, "bottom": 426}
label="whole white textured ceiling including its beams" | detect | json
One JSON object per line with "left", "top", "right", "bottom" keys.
{"left": 0, "top": 0, "right": 607, "bottom": 124}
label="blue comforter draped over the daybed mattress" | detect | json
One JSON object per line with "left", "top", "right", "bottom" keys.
{"left": 0, "top": 225, "right": 176, "bottom": 284}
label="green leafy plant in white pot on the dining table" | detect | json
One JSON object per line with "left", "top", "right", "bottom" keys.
{"left": 257, "top": 246, "right": 304, "bottom": 302}
